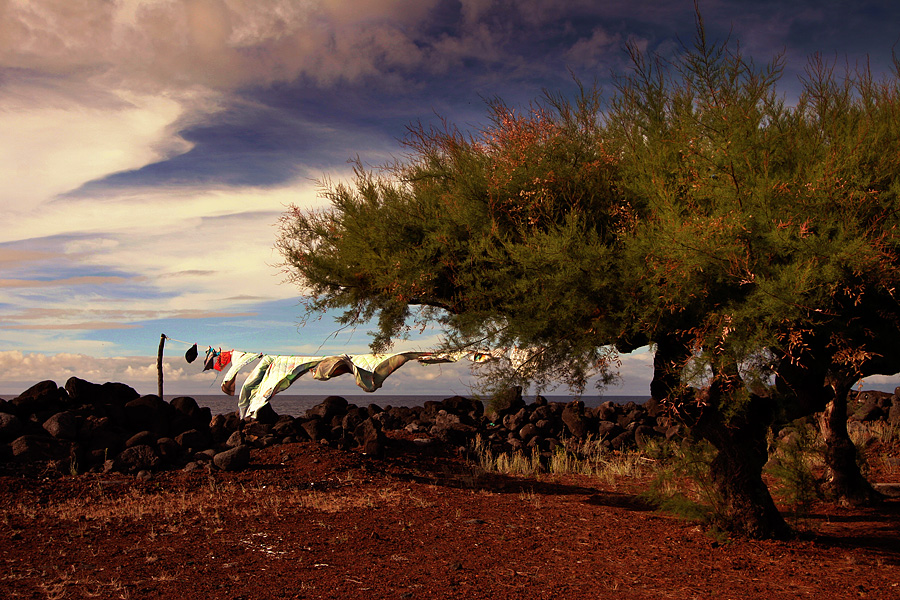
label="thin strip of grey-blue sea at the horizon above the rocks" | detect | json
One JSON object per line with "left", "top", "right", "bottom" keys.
{"left": 185, "top": 394, "right": 648, "bottom": 417}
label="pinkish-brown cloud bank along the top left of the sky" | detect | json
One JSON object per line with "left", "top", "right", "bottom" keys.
{"left": 0, "top": 0, "right": 472, "bottom": 90}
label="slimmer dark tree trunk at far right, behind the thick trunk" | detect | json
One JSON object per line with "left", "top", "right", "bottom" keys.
{"left": 819, "top": 383, "right": 883, "bottom": 505}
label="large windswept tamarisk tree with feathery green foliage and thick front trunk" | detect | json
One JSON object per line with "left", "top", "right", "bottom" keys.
{"left": 277, "top": 24, "right": 900, "bottom": 537}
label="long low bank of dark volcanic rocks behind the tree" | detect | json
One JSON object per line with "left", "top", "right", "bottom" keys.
{"left": 0, "top": 377, "right": 900, "bottom": 477}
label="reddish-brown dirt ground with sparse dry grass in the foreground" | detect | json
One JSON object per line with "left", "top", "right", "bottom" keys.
{"left": 0, "top": 436, "right": 900, "bottom": 600}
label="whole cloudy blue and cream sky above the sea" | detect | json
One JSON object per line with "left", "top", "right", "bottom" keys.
{"left": 0, "top": 0, "right": 900, "bottom": 397}
